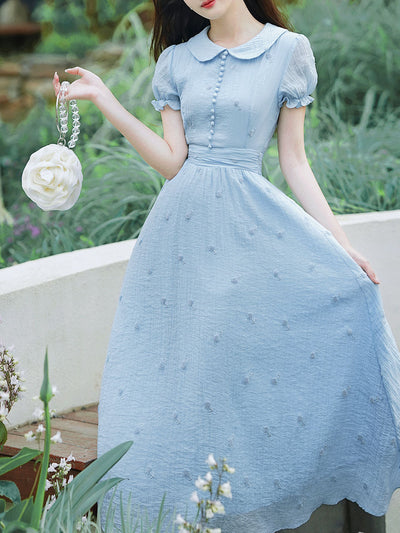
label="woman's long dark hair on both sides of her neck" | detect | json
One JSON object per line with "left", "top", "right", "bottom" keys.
{"left": 150, "top": 0, "right": 292, "bottom": 61}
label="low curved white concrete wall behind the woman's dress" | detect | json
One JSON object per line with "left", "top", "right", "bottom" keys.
{"left": 0, "top": 210, "right": 400, "bottom": 426}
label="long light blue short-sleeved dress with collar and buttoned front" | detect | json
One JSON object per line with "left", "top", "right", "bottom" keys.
{"left": 98, "top": 23, "right": 400, "bottom": 533}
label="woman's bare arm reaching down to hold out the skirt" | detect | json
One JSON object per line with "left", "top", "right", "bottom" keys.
{"left": 277, "top": 105, "right": 380, "bottom": 283}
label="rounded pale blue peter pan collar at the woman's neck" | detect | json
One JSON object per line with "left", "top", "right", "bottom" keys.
{"left": 186, "top": 22, "right": 288, "bottom": 61}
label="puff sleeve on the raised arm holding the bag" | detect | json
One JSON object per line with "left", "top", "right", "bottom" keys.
{"left": 151, "top": 44, "right": 181, "bottom": 111}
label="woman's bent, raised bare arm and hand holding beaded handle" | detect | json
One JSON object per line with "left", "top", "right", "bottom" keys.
{"left": 53, "top": 67, "right": 188, "bottom": 179}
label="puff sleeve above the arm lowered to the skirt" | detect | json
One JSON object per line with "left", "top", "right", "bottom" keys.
{"left": 278, "top": 33, "right": 318, "bottom": 108}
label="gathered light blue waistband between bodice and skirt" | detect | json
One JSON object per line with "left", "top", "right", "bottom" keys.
{"left": 188, "top": 144, "right": 263, "bottom": 174}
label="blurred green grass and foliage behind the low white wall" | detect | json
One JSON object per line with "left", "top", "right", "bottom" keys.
{"left": 0, "top": 0, "right": 400, "bottom": 267}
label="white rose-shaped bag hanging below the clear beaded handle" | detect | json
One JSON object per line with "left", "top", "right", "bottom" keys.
{"left": 22, "top": 144, "right": 83, "bottom": 211}
